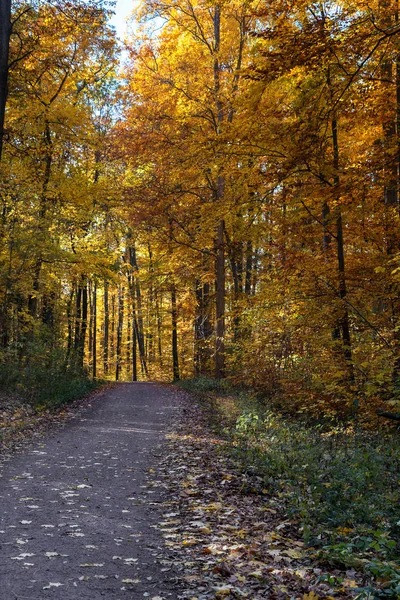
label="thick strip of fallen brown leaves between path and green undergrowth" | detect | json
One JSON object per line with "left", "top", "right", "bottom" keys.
{"left": 148, "top": 391, "right": 363, "bottom": 600}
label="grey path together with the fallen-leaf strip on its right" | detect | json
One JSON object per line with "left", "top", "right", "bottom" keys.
{"left": 0, "top": 383, "right": 396, "bottom": 600}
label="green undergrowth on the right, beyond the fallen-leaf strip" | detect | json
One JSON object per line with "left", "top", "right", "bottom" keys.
{"left": 181, "top": 378, "right": 400, "bottom": 599}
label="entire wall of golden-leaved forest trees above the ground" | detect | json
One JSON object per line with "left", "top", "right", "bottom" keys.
{"left": 0, "top": 0, "right": 400, "bottom": 421}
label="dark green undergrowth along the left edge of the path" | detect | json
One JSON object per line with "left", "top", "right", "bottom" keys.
{"left": 0, "top": 353, "right": 102, "bottom": 410}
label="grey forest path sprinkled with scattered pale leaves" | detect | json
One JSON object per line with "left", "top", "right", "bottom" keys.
{"left": 0, "top": 383, "right": 179, "bottom": 600}
